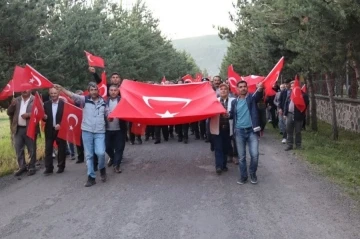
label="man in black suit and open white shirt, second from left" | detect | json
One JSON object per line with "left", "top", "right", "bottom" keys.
{"left": 43, "top": 88, "right": 66, "bottom": 175}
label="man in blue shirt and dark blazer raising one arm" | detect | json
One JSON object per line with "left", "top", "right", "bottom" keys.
{"left": 230, "top": 81, "right": 263, "bottom": 184}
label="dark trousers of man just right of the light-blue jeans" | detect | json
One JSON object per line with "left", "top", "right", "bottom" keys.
{"left": 105, "top": 130, "right": 126, "bottom": 166}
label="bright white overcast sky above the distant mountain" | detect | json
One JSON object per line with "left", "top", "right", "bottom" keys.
{"left": 117, "top": 0, "right": 233, "bottom": 39}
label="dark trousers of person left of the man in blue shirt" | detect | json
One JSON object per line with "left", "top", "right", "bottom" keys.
{"left": 211, "top": 128, "right": 231, "bottom": 169}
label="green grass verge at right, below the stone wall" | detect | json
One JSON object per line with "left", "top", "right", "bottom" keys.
{"left": 268, "top": 121, "right": 360, "bottom": 201}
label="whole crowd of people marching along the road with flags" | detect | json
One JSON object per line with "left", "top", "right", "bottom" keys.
{"left": 7, "top": 67, "right": 308, "bottom": 187}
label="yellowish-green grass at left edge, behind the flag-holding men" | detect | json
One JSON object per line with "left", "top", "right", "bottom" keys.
{"left": 0, "top": 112, "right": 45, "bottom": 176}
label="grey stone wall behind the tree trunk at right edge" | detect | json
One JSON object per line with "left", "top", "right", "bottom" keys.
{"left": 316, "top": 95, "right": 360, "bottom": 133}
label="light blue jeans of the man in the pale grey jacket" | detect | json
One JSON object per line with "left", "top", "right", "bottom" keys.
{"left": 82, "top": 130, "right": 105, "bottom": 178}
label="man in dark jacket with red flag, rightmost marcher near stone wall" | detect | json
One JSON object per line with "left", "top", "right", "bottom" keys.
{"left": 284, "top": 82, "right": 309, "bottom": 151}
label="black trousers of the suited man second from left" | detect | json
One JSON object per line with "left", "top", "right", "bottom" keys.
{"left": 45, "top": 129, "right": 66, "bottom": 171}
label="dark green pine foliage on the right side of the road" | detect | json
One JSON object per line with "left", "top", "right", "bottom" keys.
{"left": 219, "top": 0, "right": 360, "bottom": 78}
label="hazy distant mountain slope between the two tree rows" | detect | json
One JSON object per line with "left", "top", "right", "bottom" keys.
{"left": 172, "top": 35, "right": 229, "bottom": 76}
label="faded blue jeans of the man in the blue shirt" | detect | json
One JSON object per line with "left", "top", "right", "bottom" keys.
{"left": 235, "top": 128, "right": 259, "bottom": 179}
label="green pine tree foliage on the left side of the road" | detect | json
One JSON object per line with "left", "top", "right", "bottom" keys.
{"left": 0, "top": 0, "right": 198, "bottom": 90}
